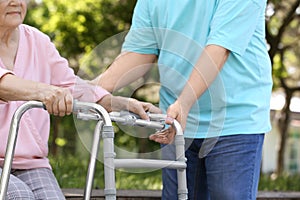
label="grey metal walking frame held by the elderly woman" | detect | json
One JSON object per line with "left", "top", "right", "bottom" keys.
{"left": 0, "top": 101, "right": 187, "bottom": 200}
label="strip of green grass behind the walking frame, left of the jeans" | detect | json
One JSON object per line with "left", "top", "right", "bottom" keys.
{"left": 50, "top": 154, "right": 161, "bottom": 190}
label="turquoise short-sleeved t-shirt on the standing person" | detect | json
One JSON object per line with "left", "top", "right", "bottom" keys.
{"left": 123, "top": 0, "right": 272, "bottom": 138}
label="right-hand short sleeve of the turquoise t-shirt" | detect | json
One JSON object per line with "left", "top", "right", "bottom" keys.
{"left": 207, "top": 0, "right": 265, "bottom": 55}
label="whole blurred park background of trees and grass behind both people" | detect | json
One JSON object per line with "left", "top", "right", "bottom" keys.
{"left": 25, "top": 0, "right": 300, "bottom": 191}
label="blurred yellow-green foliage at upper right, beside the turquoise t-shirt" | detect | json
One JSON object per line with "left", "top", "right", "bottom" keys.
{"left": 266, "top": 0, "right": 300, "bottom": 88}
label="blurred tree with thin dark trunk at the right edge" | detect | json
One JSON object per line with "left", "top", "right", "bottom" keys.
{"left": 266, "top": 0, "right": 300, "bottom": 175}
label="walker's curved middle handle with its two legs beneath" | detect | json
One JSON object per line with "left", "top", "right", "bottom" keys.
{"left": 73, "top": 102, "right": 116, "bottom": 200}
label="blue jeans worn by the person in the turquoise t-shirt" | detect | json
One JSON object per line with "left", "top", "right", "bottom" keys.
{"left": 162, "top": 134, "right": 264, "bottom": 200}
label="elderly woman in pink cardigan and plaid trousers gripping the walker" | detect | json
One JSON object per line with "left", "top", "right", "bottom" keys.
{"left": 0, "top": 0, "right": 159, "bottom": 200}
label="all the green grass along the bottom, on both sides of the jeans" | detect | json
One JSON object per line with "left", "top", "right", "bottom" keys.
{"left": 50, "top": 155, "right": 300, "bottom": 191}
